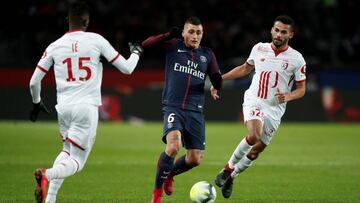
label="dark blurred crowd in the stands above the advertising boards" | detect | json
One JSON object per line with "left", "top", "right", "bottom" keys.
{"left": 0, "top": 0, "right": 360, "bottom": 70}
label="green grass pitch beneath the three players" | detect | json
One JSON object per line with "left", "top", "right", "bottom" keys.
{"left": 0, "top": 121, "right": 360, "bottom": 203}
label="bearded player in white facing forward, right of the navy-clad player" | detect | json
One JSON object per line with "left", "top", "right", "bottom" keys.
{"left": 211, "top": 15, "right": 306, "bottom": 198}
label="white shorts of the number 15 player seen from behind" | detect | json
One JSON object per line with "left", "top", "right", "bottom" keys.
{"left": 55, "top": 104, "right": 99, "bottom": 151}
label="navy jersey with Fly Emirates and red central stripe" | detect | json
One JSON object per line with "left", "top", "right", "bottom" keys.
{"left": 162, "top": 39, "right": 220, "bottom": 111}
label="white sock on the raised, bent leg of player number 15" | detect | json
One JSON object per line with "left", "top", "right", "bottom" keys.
{"left": 45, "top": 157, "right": 79, "bottom": 181}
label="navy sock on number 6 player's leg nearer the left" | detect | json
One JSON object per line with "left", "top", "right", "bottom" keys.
{"left": 155, "top": 152, "right": 174, "bottom": 188}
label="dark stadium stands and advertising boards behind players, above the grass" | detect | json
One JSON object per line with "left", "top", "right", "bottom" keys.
{"left": 0, "top": 0, "right": 360, "bottom": 122}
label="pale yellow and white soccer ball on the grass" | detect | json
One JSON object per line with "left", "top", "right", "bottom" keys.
{"left": 190, "top": 181, "right": 216, "bottom": 203}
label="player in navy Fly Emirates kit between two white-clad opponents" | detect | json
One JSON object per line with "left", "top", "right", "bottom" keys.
{"left": 142, "top": 17, "right": 222, "bottom": 203}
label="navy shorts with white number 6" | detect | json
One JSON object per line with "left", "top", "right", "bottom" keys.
{"left": 162, "top": 106, "right": 205, "bottom": 150}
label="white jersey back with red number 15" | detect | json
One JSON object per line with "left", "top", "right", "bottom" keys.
{"left": 37, "top": 31, "right": 119, "bottom": 105}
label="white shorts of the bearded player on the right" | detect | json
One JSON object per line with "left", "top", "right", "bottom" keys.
{"left": 243, "top": 100, "right": 281, "bottom": 145}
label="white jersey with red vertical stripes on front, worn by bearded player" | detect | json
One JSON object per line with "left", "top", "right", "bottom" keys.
{"left": 244, "top": 43, "right": 306, "bottom": 119}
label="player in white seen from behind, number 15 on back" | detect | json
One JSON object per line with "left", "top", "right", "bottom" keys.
{"left": 30, "top": 2, "right": 143, "bottom": 203}
